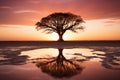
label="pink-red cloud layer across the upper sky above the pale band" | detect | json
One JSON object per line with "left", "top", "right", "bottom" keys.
{"left": 0, "top": 0, "right": 120, "bottom": 24}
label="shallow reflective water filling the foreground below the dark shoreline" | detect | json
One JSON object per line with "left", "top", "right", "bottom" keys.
{"left": 0, "top": 46, "right": 120, "bottom": 80}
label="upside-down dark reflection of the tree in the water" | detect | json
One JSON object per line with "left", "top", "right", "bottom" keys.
{"left": 36, "top": 49, "right": 83, "bottom": 78}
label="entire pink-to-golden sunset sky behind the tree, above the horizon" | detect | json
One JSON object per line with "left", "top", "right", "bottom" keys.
{"left": 0, "top": 0, "right": 120, "bottom": 41}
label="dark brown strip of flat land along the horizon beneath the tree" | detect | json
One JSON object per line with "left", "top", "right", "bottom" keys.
{"left": 0, "top": 40, "right": 120, "bottom": 47}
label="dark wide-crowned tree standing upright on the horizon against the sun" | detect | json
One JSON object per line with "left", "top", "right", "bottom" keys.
{"left": 36, "top": 13, "right": 84, "bottom": 41}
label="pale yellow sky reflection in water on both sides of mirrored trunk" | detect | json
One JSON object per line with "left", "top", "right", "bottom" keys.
{"left": 21, "top": 48, "right": 105, "bottom": 59}
